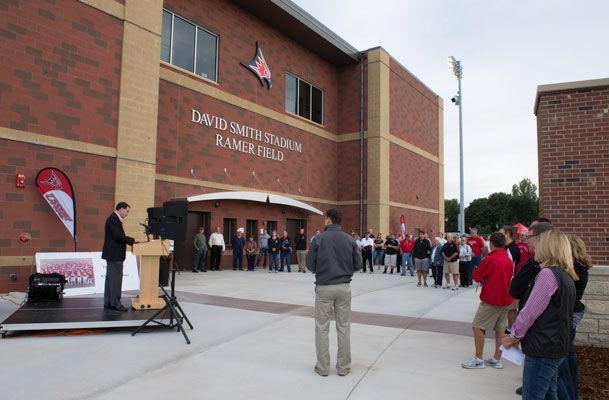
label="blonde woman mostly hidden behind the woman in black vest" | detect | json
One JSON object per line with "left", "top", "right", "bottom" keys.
{"left": 558, "top": 233, "right": 592, "bottom": 399}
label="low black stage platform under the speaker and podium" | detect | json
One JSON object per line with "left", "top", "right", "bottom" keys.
{"left": 0, "top": 297, "right": 169, "bottom": 337}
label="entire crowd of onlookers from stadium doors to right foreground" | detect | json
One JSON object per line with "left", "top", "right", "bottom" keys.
{"left": 193, "top": 218, "right": 592, "bottom": 399}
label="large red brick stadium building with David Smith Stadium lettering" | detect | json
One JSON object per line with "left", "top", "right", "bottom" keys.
{"left": 0, "top": 0, "right": 444, "bottom": 292}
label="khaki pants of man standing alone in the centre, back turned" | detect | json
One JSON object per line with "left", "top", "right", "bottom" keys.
{"left": 315, "top": 283, "right": 351, "bottom": 374}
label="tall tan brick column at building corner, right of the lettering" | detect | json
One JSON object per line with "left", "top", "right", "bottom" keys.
{"left": 366, "top": 48, "right": 390, "bottom": 233}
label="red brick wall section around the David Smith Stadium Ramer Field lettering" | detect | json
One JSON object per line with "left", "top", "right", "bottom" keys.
{"left": 157, "top": 80, "right": 338, "bottom": 200}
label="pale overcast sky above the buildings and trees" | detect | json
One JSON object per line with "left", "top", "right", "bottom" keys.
{"left": 293, "top": 0, "right": 609, "bottom": 205}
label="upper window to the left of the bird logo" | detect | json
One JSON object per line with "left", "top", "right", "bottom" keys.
{"left": 161, "top": 10, "right": 218, "bottom": 81}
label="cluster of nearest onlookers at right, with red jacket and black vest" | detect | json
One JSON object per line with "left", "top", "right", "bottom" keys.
{"left": 461, "top": 218, "right": 592, "bottom": 399}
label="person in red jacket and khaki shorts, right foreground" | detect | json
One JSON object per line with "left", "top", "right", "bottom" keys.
{"left": 461, "top": 232, "right": 514, "bottom": 369}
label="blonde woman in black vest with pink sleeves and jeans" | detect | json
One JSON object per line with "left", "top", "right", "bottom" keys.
{"left": 503, "top": 228, "right": 578, "bottom": 400}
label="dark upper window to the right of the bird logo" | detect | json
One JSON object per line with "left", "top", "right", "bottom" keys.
{"left": 285, "top": 74, "right": 324, "bottom": 124}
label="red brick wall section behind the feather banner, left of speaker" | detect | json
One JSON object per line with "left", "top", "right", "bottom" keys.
{"left": 0, "top": 139, "right": 115, "bottom": 293}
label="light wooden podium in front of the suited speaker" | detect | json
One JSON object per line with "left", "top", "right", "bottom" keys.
{"left": 131, "top": 240, "right": 169, "bottom": 310}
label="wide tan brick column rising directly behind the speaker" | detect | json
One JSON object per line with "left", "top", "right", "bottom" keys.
{"left": 114, "top": 0, "right": 163, "bottom": 238}
